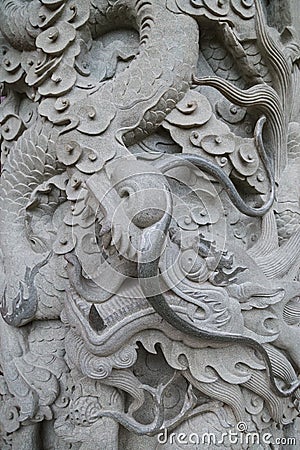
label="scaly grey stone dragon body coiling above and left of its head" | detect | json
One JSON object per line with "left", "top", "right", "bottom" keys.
{"left": 0, "top": 0, "right": 198, "bottom": 326}
